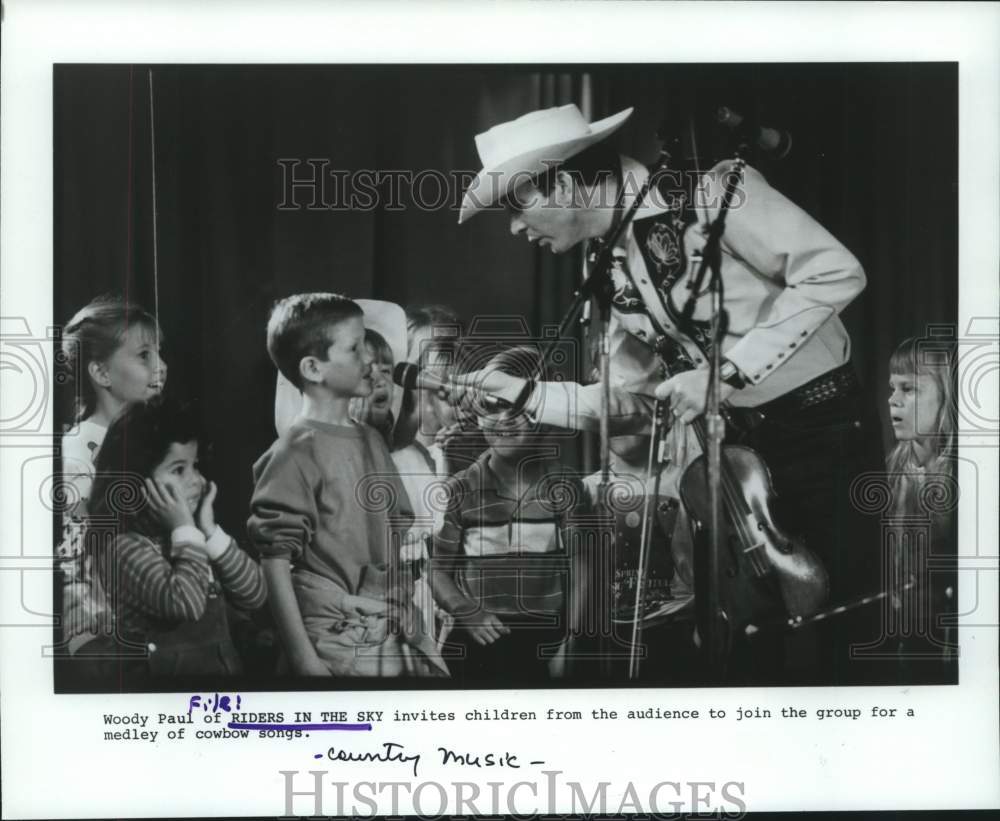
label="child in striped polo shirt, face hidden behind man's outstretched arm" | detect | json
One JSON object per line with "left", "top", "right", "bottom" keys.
{"left": 430, "top": 348, "right": 593, "bottom": 684}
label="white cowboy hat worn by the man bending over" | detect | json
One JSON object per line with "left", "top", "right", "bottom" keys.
{"left": 458, "top": 103, "right": 632, "bottom": 224}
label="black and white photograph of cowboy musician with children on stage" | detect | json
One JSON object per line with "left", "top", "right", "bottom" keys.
{"left": 53, "top": 63, "right": 960, "bottom": 691}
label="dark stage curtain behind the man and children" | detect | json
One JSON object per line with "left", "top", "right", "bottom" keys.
{"left": 54, "top": 64, "right": 958, "bottom": 533}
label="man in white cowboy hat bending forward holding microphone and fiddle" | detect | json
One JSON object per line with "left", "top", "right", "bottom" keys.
{"left": 457, "top": 105, "right": 881, "bottom": 679}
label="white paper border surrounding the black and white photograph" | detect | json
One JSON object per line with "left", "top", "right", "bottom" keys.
{"left": 0, "top": 0, "right": 1000, "bottom": 818}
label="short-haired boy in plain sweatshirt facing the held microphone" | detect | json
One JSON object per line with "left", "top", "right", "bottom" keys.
{"left": 248, "top": 293, "right": 443, "bottom": 676}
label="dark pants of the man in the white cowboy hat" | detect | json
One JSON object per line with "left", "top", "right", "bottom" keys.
{"left": 726, "top": 393, "right": 884, "bottom": 684}
